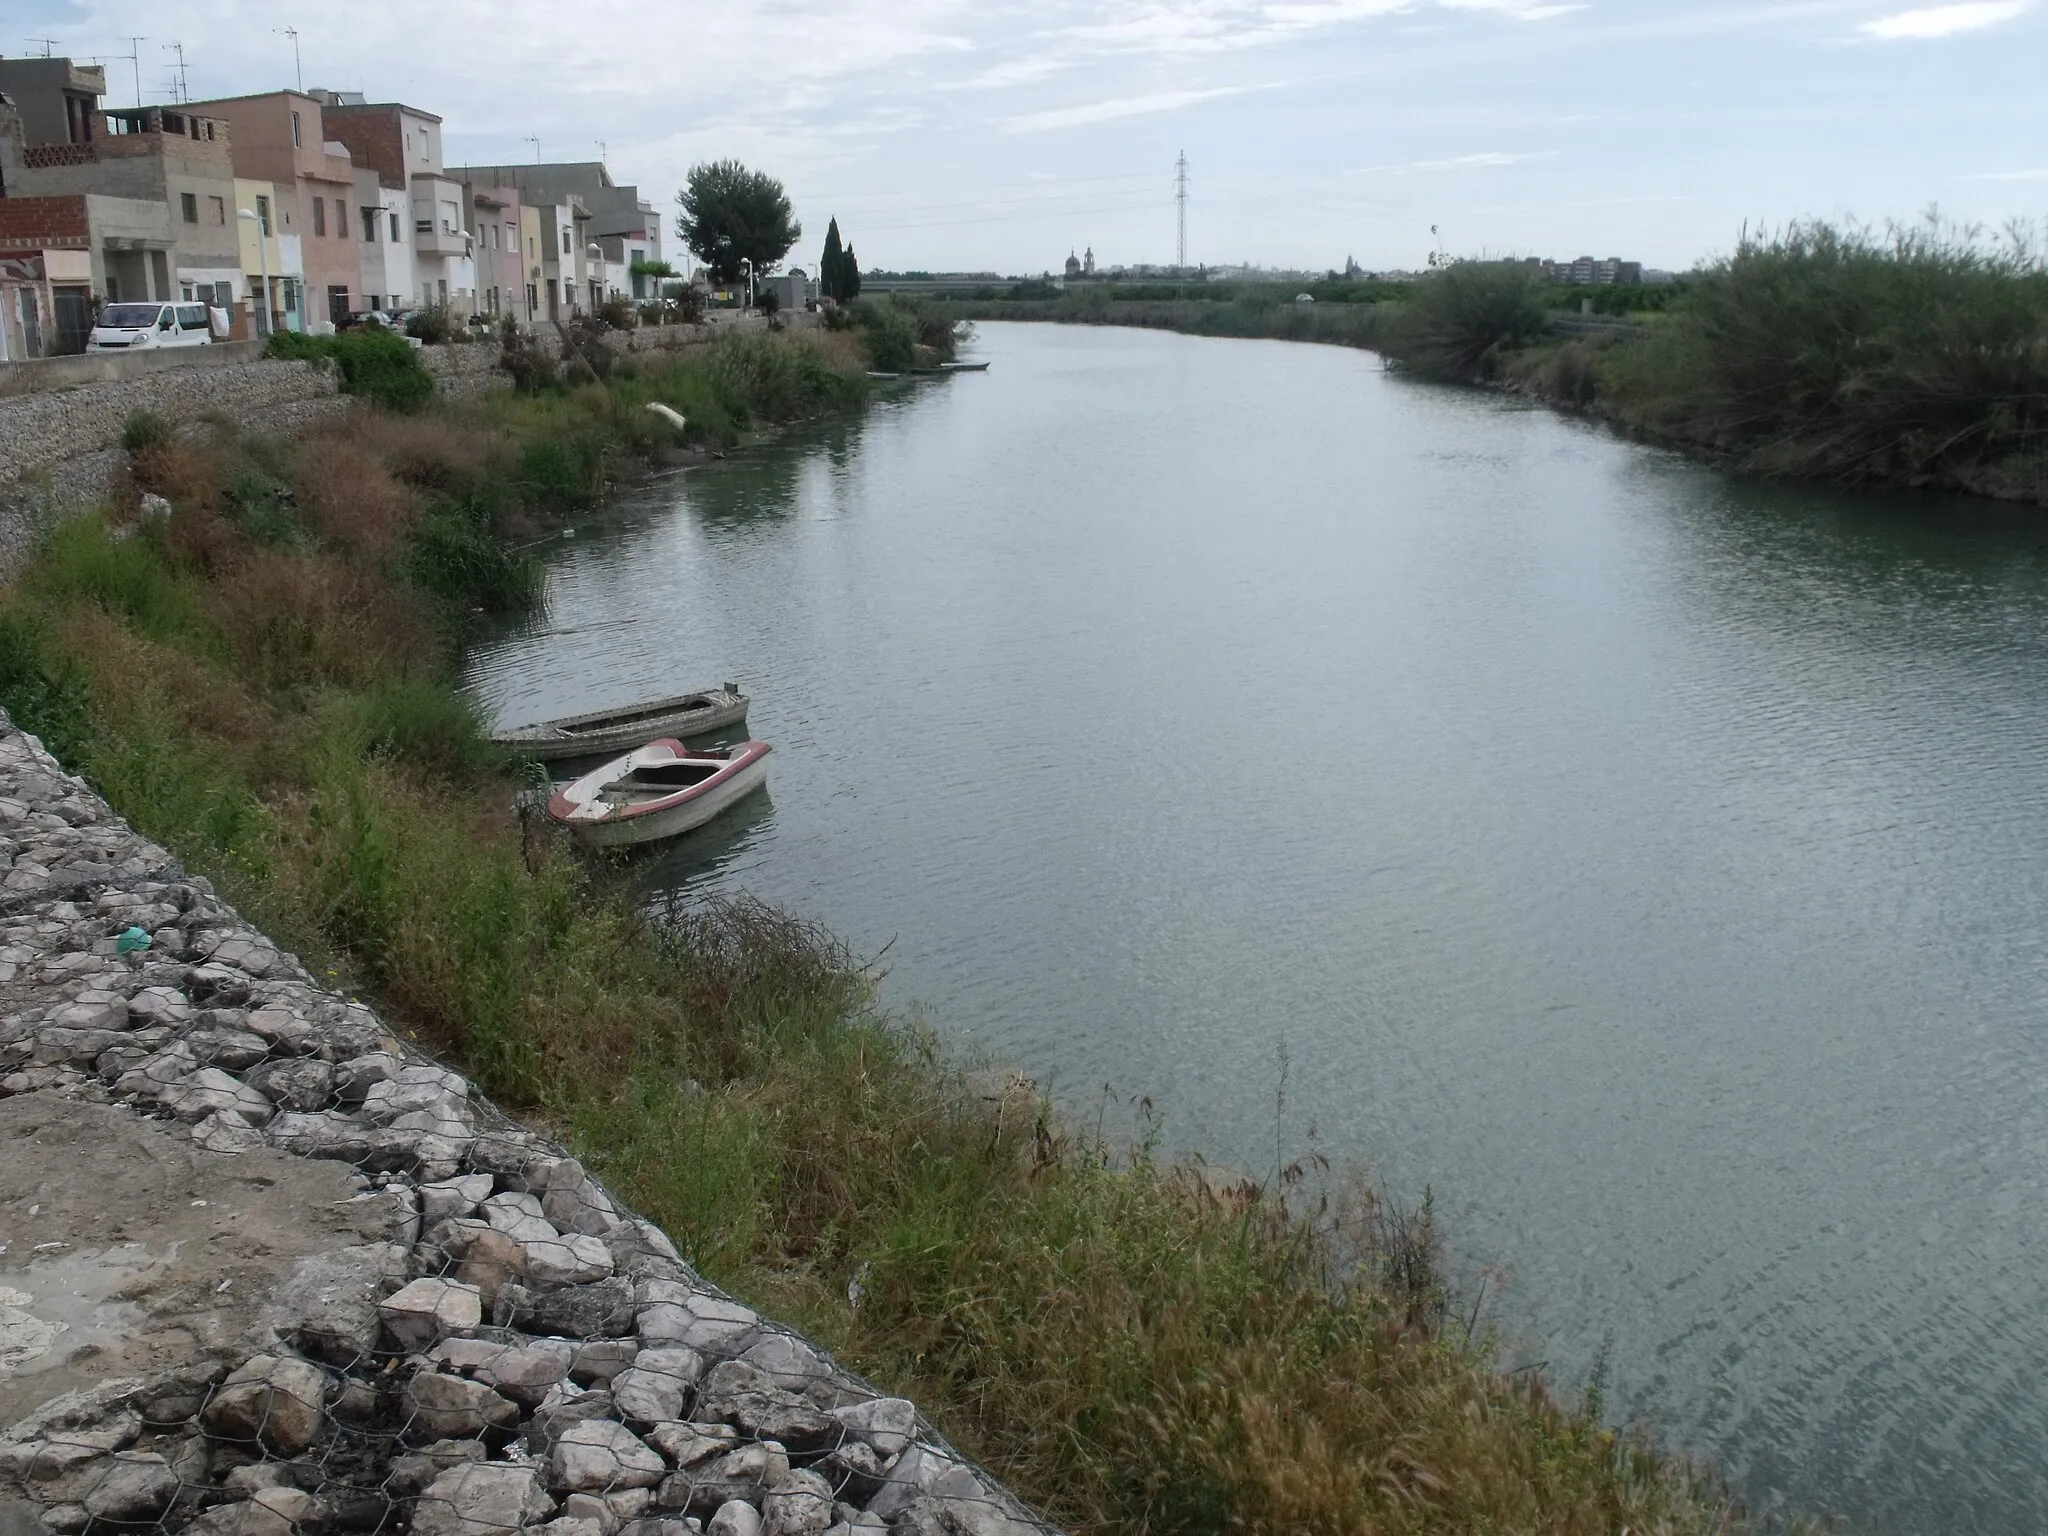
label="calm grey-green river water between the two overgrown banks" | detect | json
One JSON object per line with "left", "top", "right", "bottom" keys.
{"left": 473, "top": 326, "right": 2048, "bottom": 1536}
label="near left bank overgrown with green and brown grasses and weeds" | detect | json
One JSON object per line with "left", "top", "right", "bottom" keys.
{"left": 0, "top": 338, "right": 1741, "bottom": 1536}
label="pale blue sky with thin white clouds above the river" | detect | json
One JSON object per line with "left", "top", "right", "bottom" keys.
{"left": 16, "top": 0, "right": 2048, "bottom": 274}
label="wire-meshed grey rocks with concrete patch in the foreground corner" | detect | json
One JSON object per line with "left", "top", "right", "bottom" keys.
{"left": 0, "top": 717, "right": 1047, "bottom": 1536}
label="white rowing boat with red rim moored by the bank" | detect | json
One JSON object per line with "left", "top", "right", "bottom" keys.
{"left": 547, "top": 741, "right": 770, "bottom": 848}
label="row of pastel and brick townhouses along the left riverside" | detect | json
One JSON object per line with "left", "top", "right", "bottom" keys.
{"left": 0, "top": 57, "right": 662, "bottom": 358}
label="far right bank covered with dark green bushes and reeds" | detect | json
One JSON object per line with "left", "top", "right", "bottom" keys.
{"left": 958, "top": 223, "right": 2048, "bottom": 504}
